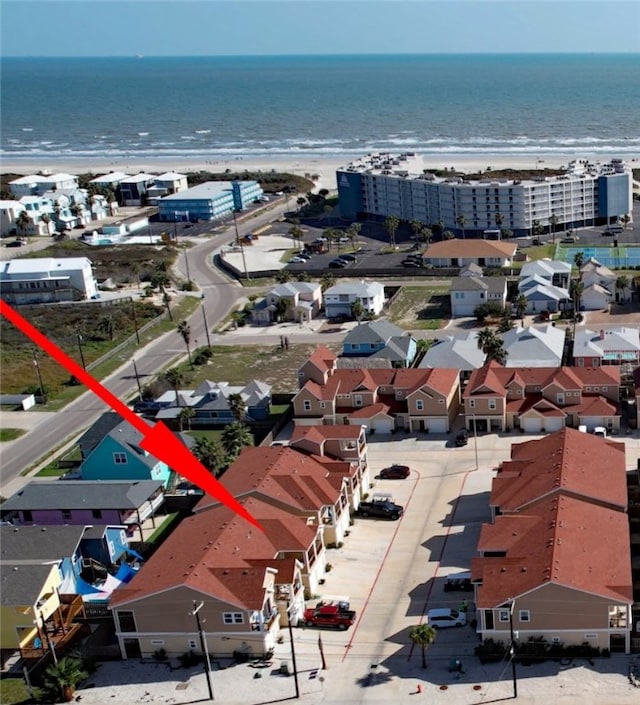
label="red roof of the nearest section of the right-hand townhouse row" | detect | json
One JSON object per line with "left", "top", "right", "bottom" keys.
{"left": 472, "top": 496, "right": 633, "bottom": 609}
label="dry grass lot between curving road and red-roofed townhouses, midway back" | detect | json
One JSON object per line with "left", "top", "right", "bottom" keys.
{"left": 154, "top": 345, "right": 341, "bottom": 393}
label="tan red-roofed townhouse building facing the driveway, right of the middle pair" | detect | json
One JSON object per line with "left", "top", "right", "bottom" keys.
{"left": 462, "top": 360, "right": 620, "bottom": 433}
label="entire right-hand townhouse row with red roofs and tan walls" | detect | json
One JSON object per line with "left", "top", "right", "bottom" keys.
{"left": 471, "top": 428, "right": 633, "bottom": 653}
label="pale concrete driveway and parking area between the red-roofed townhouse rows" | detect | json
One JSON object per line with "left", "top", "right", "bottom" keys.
{"left": 72, "top": 431, "right": 640, "bottom": 705}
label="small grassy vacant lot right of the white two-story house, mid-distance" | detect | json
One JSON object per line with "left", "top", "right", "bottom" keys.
{"left": 387, "top": 286, "right": 450, "bottom": 330}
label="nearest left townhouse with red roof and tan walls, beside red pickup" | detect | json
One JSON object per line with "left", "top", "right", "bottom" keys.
{"left": 109, "top": 496, "right": 308, "bottom": 658}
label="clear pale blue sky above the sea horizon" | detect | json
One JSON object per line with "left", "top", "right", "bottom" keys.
{"left": 0, "top": 0, "right": 640, "bottom": 57}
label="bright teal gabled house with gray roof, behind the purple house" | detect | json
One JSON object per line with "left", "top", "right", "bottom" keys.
{"left": 78, "top": 413, "right": 191, "bottom": 487}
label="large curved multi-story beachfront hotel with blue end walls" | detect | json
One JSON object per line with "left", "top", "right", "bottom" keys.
{"left": 336, "top": 152, "right": 632, "bottom": 237}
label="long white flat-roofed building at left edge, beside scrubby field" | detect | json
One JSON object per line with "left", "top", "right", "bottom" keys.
{"left": 0, "top": 257, "right": 99, "bottom": 304}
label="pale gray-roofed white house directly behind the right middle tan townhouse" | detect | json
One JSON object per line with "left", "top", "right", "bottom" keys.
{"left": 502, "top": 323, "right": 565, "bottom": 367}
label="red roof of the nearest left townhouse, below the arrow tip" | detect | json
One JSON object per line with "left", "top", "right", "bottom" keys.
{"left": 110, "top": 497, "right": 316, "bottom": 608}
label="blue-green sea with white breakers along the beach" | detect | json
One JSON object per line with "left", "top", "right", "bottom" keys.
{"left": 0, "top": 55, "right": 640, "bottom": 160}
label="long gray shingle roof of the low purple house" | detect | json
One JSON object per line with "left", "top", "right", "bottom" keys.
{"left": 0, "top": 480, "right": 163, "bottom": 514}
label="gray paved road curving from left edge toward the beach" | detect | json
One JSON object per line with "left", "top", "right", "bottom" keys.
{"left": 0, "top": 204, "right": 285, "bottom": 496}
